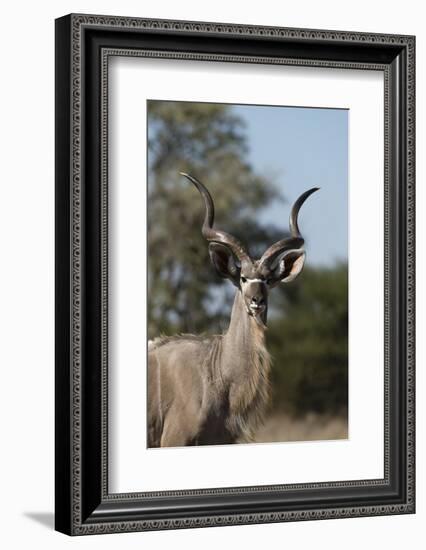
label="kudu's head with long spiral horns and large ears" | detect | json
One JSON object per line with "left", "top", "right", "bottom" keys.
{"left": 181, "top": 172, "right": 319, "bottom": 326}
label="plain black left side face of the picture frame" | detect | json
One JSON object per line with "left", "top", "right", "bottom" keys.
{"left": 55, "top": 17, "right": 72, "bottom": 534}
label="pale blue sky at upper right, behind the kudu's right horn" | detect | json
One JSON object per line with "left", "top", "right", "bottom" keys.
{"left": 233, "top": 105, "right": 349, "bottom": 265}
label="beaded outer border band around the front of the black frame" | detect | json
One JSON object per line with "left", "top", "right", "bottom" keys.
{"left": 61, "top": 14, "right": 415, "bottom": 535}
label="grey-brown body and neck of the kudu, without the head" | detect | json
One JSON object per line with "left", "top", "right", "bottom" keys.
{"left": 148, "top": 291, "right": 270, "bottom": 447}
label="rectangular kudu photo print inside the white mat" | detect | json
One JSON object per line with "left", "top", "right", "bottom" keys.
{"left": 147, "top": 100, "right": 349, "bottom": 447}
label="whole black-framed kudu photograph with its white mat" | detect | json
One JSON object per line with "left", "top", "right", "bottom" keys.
{"left": 55, "top": 14, "right": 415, "bottom": 535}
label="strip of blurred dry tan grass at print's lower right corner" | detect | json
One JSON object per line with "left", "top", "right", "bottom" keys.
{"left": 251, "top": 413, "right": 348, "bottom": 443}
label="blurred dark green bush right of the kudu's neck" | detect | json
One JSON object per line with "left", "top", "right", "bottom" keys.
{"left": 267, "top": 264, "right": 348, "bottom": 413}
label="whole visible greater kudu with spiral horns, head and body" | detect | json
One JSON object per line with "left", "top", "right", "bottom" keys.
{"left": 148, "top": 173, "right": 318, "bottom": 447}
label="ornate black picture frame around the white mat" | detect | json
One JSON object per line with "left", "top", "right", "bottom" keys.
{"left": 55, "top": 15, "right": 415, "bottom": 535}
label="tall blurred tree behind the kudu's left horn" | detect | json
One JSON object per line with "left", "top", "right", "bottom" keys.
{"left": 148, "top": 101, "right": 282, "bottom": 338}
